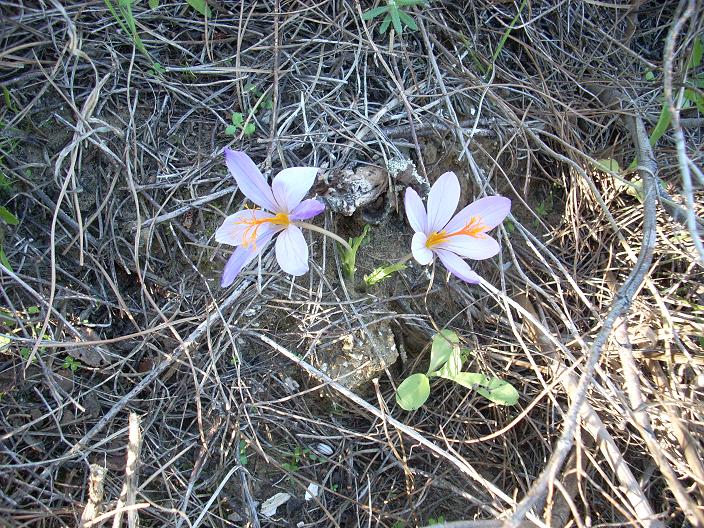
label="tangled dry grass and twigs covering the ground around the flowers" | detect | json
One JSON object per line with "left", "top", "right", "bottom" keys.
{"left": 0, "top": 0, "right": 704, "bottom": 528}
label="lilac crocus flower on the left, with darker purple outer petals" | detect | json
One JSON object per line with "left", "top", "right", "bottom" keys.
{"left": 215, "top": 149, "right": 325, "bottom": 288}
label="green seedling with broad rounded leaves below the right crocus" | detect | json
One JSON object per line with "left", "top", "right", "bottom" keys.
{"left": 396, "top": 330, "right": 518, "bottom": 411}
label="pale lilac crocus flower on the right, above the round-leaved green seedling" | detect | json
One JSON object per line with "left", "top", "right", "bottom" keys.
{"left": 404, "top": 172, "right": 511, "bottom": 284}
